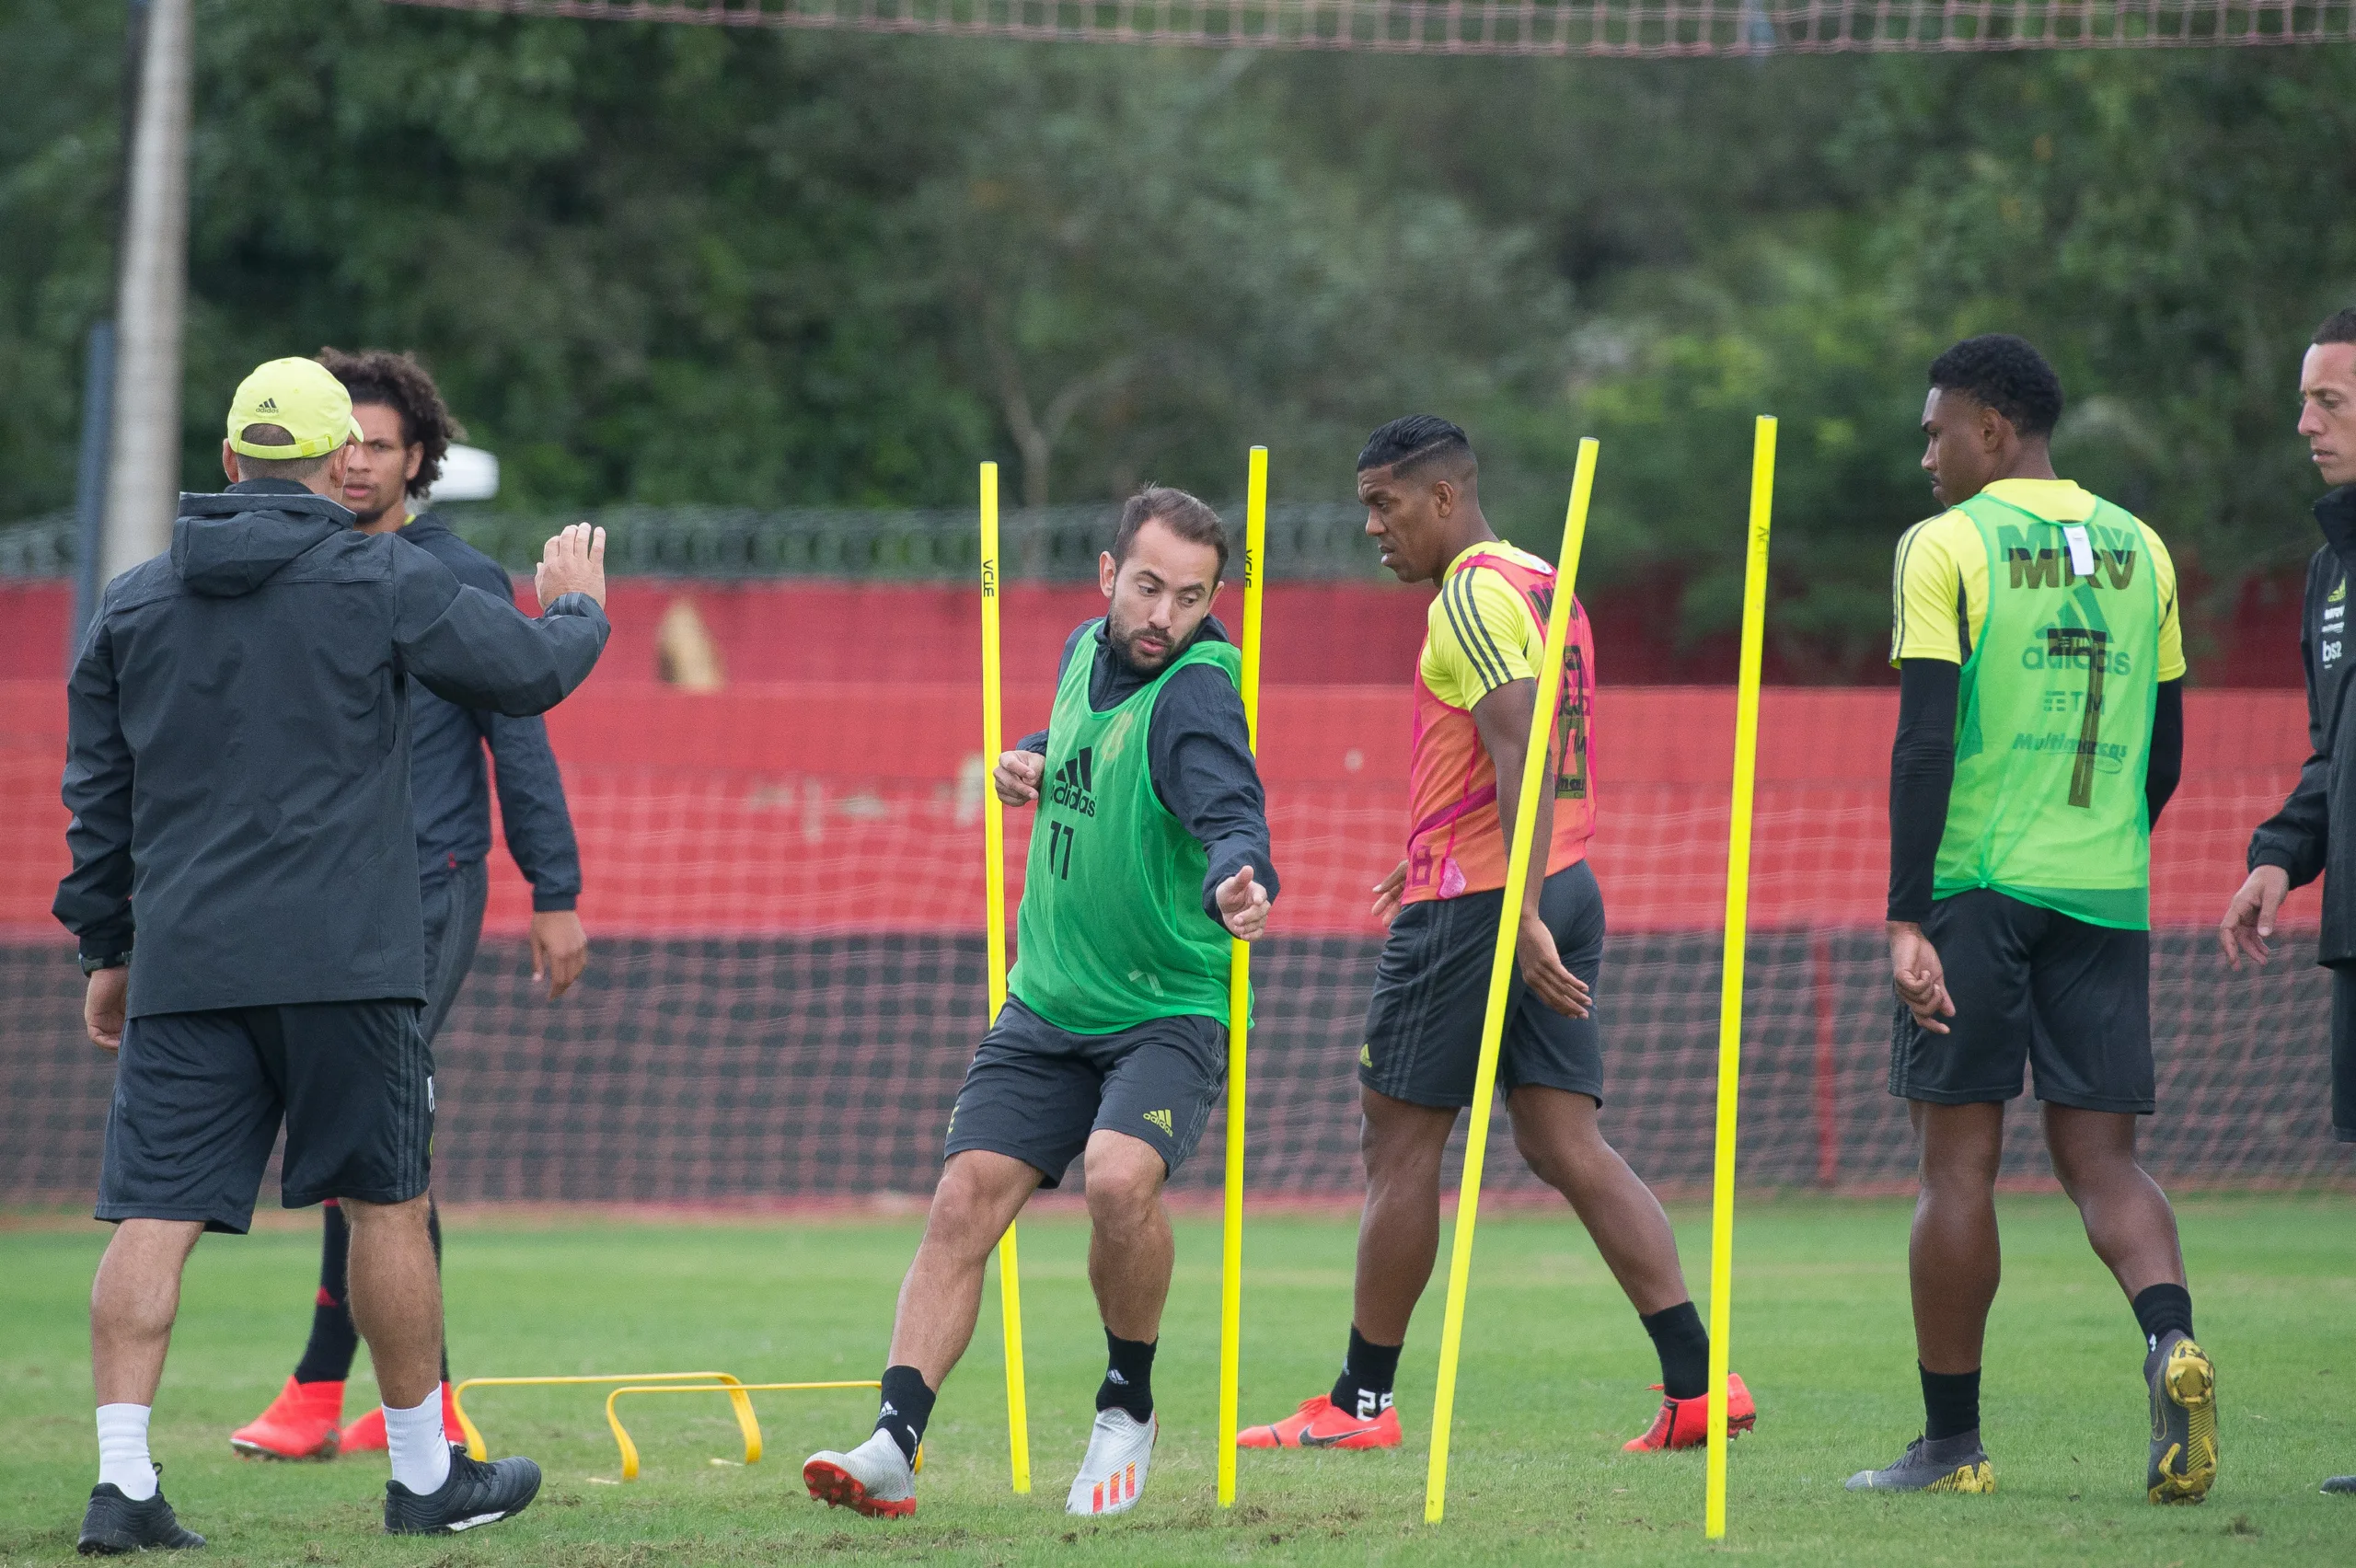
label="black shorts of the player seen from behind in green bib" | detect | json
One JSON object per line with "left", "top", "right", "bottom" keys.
{"left": 1889, "top": 888, "right": 2154, "bottom": 1116}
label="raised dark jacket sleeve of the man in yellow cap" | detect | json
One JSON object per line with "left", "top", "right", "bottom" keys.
{"left": 394, "top": 535, "right": 613, "bottom": 716}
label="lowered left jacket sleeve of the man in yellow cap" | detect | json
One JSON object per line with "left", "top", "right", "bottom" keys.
{"left": 50, "top": 605, "right": 134, "bottom": 958}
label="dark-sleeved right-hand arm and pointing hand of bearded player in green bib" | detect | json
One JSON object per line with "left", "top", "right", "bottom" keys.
{"left": 1145, "top": 664, "right": 1277, "bottom": 926}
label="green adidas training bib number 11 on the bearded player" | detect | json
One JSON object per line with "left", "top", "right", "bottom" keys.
{"left": 1006, "top": 621, "right": 1244, "bottom": 1033}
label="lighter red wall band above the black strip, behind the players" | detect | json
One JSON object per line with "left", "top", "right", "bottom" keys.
{"left": 0, "top": 673, "right": 2311, "bottom": 935}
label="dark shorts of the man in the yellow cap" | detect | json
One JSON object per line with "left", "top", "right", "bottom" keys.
{"left": 97, "top": 1000, "right": 433, "bottom": 1236}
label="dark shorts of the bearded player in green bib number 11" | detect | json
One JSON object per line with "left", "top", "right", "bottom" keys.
{"left": 947, "top": 996, "right": 1228, "bottom": 1187}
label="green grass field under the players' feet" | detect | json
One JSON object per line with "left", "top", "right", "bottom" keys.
{"left": 0, "top": 1196, "right": 2356, "bottom": 1568}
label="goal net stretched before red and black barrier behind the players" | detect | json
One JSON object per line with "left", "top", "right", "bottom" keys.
{"left": 0, "top": 677, "right": 2356, "bottom": 1203}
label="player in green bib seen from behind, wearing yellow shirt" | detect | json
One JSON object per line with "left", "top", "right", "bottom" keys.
{"left": 1850, "top": 337, "right": 2217, "bottom": 1502}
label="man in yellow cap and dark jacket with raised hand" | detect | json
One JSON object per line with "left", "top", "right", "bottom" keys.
{"left": 54, "top": 358, "right": 610, "bottom": 1554}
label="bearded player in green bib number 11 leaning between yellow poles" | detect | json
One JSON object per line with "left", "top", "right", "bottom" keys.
{"left": 803, "top": 488, "right": 1277, "bottom": 1516}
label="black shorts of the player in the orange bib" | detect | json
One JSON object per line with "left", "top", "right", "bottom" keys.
{"left": 1357, "top": 861, "right": 1604, "bottom": 1107}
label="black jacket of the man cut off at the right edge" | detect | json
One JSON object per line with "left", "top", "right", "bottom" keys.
{"left": 2250, "top": 485, "right": 2356, "bottom": 963}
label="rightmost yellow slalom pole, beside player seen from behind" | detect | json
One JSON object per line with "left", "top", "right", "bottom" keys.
{"left": 1701, "top": 414, "right": 1774, "bottom": 1539}
